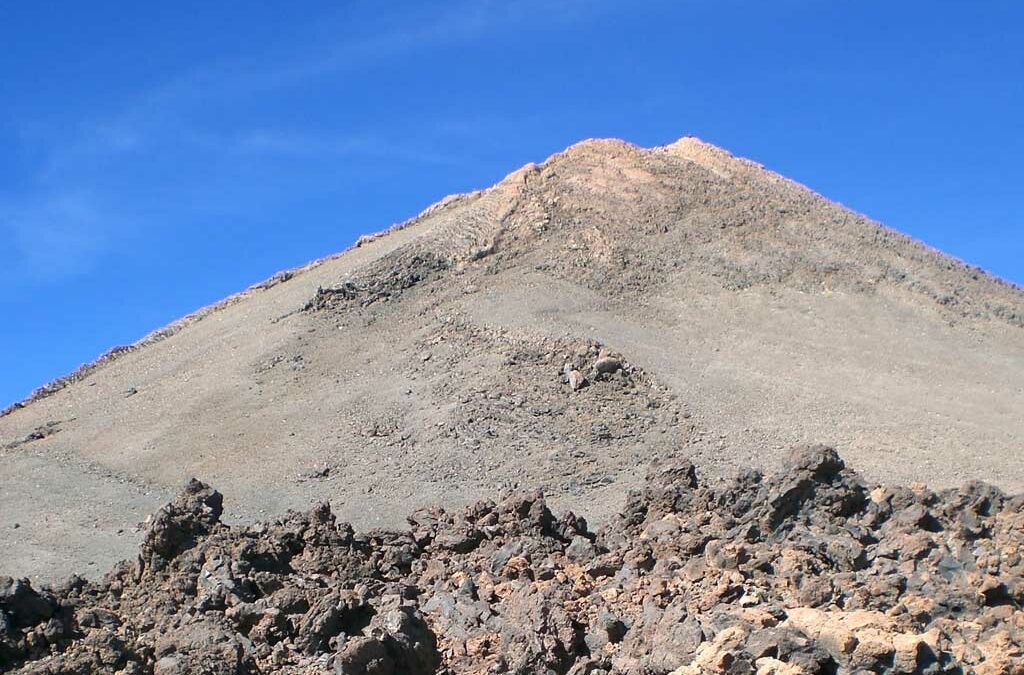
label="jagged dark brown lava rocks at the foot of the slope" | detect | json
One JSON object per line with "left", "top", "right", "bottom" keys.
{"left": 0, "top": 447, "right": 1024, "bottom": 675}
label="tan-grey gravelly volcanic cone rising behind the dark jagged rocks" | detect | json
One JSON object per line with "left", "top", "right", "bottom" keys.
{"left": 0, "top": 138, "right": 1024, "bottom": 579}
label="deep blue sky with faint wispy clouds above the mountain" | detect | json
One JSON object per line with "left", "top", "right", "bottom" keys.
{"left": 0, "top": 0, "right": 1024, "bottom": 407}
